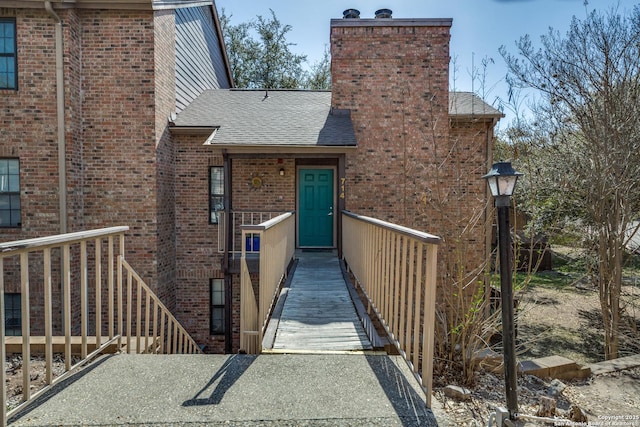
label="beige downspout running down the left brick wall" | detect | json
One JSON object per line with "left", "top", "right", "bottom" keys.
{"left": 44, "top": 1, "right": 67, "bottom": 234}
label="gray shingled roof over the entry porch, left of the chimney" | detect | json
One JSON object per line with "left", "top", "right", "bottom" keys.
{"left": 173, "top": 89, "right": 356, "bottom": 147}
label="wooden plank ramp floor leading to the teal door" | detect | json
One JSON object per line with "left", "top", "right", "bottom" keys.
{"left": 271, "top": 252, "right": 373, "bottom": 353}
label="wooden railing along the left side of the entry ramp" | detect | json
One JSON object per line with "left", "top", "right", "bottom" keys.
{"left": 240, "top": 212, "right": 295, "bottom": 354}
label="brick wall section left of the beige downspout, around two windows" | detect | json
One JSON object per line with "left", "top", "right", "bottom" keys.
{"left": 0, "top": 10, "right": 59, "bottom": 241}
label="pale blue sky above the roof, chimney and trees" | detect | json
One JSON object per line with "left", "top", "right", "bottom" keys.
{"left": 216, "top": 0, "right": 639, "bottom": 127}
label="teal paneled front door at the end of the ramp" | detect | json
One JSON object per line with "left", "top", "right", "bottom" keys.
{"left": 298, "top": 169, "right": 334, "bottom": 247}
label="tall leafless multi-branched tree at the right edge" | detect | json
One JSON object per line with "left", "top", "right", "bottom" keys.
{"left": 501, "top": 6, "right": 640, "bottom": 359}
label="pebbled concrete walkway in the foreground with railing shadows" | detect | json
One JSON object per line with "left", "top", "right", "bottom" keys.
{"left": 10, "top": 354, "right": 438, "bottom": 426}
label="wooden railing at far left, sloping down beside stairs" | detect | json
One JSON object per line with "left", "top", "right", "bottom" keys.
{"left": 0, "top": 227, "right": 200, "bottom": 426}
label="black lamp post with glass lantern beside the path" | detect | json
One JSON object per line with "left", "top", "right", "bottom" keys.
{"left": 483, "top": 162, "right": 522, "bottom": 419}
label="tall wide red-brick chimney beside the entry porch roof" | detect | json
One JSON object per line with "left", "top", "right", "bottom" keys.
{"left": 331, "top": 9, "right": 452, "bottom": 226}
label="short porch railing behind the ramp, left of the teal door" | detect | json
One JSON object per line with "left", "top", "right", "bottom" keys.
{"left": 218, "top": 211, "right": 283, "bottom": 259}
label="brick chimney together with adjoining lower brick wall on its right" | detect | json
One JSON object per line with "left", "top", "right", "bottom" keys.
{"left": 331, "top": 20, "right": 493, "bottom": 297}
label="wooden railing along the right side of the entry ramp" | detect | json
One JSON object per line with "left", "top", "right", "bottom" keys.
{"left": 342, "top": 212, "right": 440, "bottom": 407}
